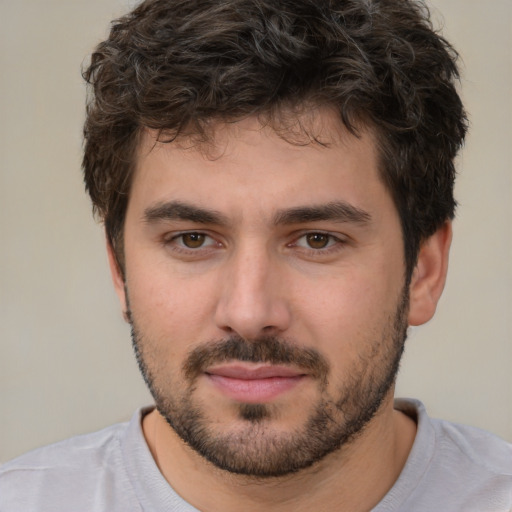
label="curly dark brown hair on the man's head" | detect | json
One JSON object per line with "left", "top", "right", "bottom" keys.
{"left": 83, "top": 0, "right": 467, "bottom": 278}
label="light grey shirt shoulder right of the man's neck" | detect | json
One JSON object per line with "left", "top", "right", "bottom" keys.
{"left": 388, "top": 400, "right": 512, "bottom": 512}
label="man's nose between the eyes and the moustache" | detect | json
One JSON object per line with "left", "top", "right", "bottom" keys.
{"left": 215, "top": 244, "right": 291, "bottom": 340}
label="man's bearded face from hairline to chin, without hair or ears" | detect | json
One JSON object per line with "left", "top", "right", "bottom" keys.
{"left": 118, "top": 112, "right": 408, "bottom": 477}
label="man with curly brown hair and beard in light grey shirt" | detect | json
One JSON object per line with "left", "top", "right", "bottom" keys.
{"left": 0, "top": 0, "right": 512, "bottom": 512}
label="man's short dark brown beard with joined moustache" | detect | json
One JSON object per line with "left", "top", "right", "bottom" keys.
{"left": 130, "top": 289, "right": 409, "bottom": 478}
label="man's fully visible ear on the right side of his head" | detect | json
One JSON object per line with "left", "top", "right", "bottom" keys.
{"left": 409, "top": 222, "right": 452, "bottom": 325}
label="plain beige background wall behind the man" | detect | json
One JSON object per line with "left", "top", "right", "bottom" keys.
{"left": 0, "top": 0, "right": 512, "bottom": 461}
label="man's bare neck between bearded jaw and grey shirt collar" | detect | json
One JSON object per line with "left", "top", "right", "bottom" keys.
{"left": 143, "top": 396, "right": 416, "bottom": 512}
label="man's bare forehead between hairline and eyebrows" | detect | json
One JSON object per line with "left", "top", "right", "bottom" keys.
{"left": 130, "top": 109, "right": 387, "bottom": 221}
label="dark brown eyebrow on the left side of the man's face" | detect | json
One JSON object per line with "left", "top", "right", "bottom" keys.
{"left": 143, "top": 201, "right": 228, "bottom": 225}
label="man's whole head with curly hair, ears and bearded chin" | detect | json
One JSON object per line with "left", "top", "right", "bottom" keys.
{"left": 84, "top": 0, "right": 465, "bottom": 476}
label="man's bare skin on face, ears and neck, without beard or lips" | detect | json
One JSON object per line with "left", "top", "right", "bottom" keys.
{"left": 109, "top": 111, "right": 451, "bottom": 512}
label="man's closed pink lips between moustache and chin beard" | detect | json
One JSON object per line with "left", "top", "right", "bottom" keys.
{"left": 205, "top": 363, "right": 308, "bottom": 404}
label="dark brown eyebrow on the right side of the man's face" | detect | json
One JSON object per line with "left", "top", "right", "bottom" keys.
{"left": 274, "top": 201, "right": 372, "bottom": 225}
